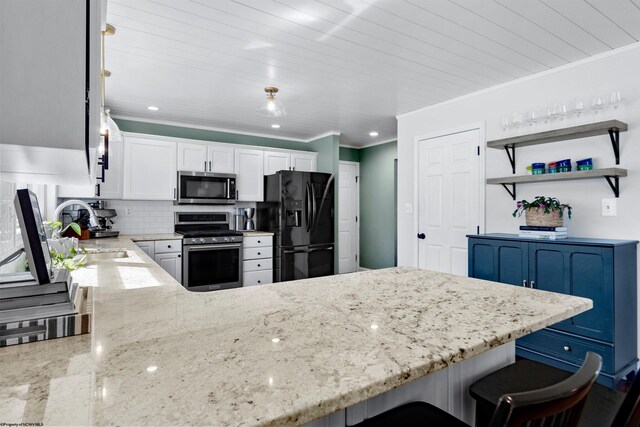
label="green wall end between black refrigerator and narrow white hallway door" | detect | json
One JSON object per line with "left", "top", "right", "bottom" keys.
{"left": 308, "top": 135, "right": 340, "bottom": 273}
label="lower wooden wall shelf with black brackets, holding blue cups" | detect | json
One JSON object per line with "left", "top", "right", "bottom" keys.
{"left": 487, "top": 168, "right": 627, "bottom": 200}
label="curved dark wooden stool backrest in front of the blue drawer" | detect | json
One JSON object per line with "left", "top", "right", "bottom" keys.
{"left": 490, "top": 352, "right": 602, "bottom": 427}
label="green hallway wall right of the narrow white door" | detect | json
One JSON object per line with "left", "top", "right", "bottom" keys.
{"left": 360, "top": 141, "right": 398, "bottom": 268}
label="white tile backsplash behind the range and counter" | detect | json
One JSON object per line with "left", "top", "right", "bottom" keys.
{"left": 58, "top": 200, "right": 256, "bottom": 234}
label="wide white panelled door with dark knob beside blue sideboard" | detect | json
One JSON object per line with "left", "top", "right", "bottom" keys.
{"left": 418, "top": 129, "right": 482, "bottom": 276}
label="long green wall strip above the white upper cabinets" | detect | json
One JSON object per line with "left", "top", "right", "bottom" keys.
{"left": 114, "top": 119, "right": 315, "bottom": 151}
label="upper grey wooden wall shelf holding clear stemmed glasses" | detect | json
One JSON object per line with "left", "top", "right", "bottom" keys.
{"left": 487, "top": 120, "right": 627, "bottom": 149}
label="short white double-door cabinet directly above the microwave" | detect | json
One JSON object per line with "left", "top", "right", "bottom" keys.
{"left": 178, "top": 141, "right": 235, "bottom": 173}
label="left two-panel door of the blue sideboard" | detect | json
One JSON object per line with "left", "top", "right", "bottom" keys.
{"left": 469, "top": 238, "right": 529, "bottom": 286}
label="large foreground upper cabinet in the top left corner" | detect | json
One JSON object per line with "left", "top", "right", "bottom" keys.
{"left": 0, "top": 0, "right": 102, "bottom": 185}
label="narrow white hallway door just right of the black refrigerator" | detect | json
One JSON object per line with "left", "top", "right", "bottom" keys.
{"left": 338, "top": 162, "right": 360, "bottom": 273}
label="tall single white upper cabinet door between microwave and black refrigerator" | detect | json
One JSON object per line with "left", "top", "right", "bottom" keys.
{"left": 235, "top": 149, "right": 264, "bottom": 202}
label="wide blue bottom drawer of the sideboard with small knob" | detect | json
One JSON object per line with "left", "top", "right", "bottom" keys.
{"left": 517, "top": 329, "right": 614, "bottom": 373}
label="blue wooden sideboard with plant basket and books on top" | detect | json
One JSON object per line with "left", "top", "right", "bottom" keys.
{"left": 467, "top": 233, "right": 638, "bottom": 387}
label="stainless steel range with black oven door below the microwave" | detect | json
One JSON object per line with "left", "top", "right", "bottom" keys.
{"left": 175, "top": 212, "right": 242, "bottom": 292}
